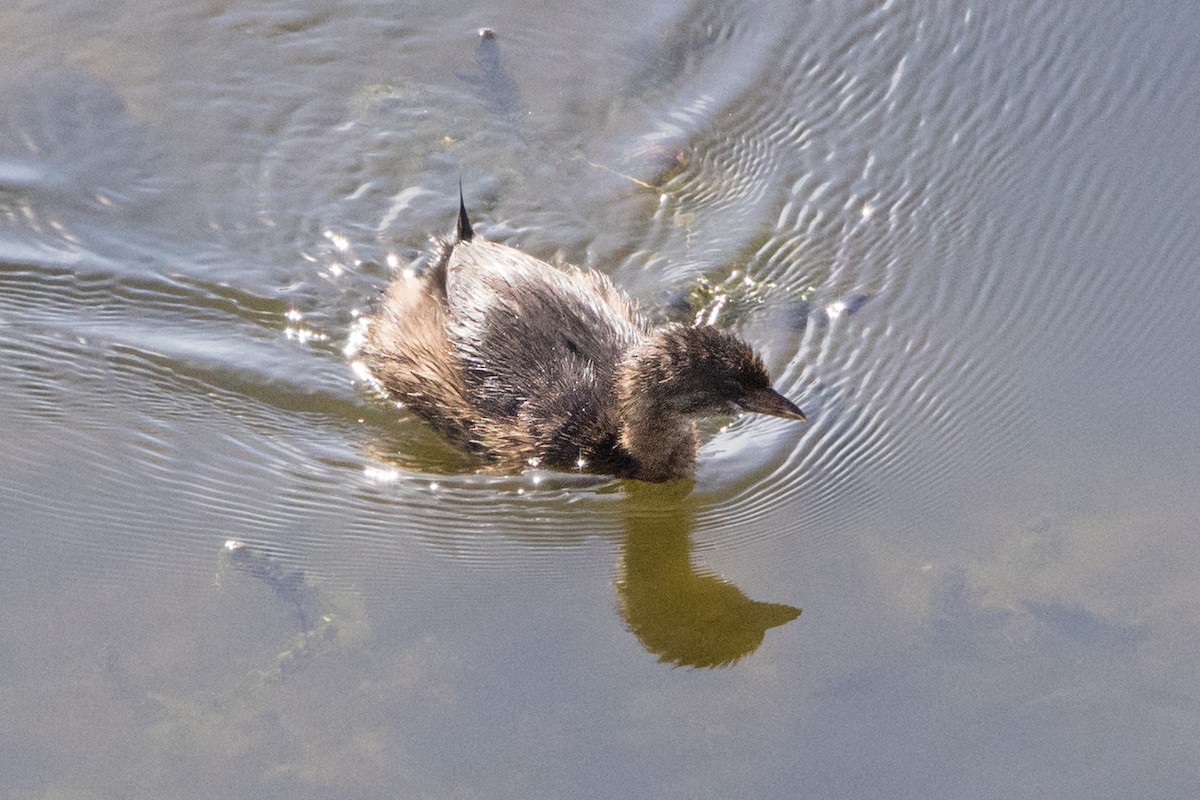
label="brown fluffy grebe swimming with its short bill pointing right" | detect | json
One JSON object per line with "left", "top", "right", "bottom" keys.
{"left": 359, "top": 197, "right": 805, "bottom": 481}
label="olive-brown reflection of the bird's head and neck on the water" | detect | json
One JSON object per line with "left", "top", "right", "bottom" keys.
{"left": 617, "top": 482, "right": 800, "bottom": 668}
